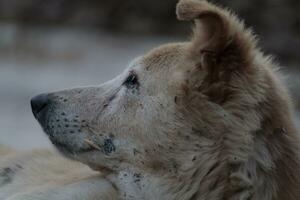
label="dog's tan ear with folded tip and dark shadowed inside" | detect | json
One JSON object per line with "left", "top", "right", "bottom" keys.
{"left": 176, "top": 0, "right": 256, "bottom": 71}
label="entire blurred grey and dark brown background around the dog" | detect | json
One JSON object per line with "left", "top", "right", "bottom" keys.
{"left": 0, "top": 0, "right": 300, "bottom": 149}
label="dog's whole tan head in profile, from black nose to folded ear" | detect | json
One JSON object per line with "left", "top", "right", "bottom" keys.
{"left": 32, "top": 0, "right": 284, "bottom": 178}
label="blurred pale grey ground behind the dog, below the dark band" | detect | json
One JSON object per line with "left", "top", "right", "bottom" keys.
{"left": 0, "top": 24, "right": 300, "bottom": 149}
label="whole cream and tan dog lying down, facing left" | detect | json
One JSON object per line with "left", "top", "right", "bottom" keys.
{"left": 0, "top": 0, "right": 300, "bottom": 200}
